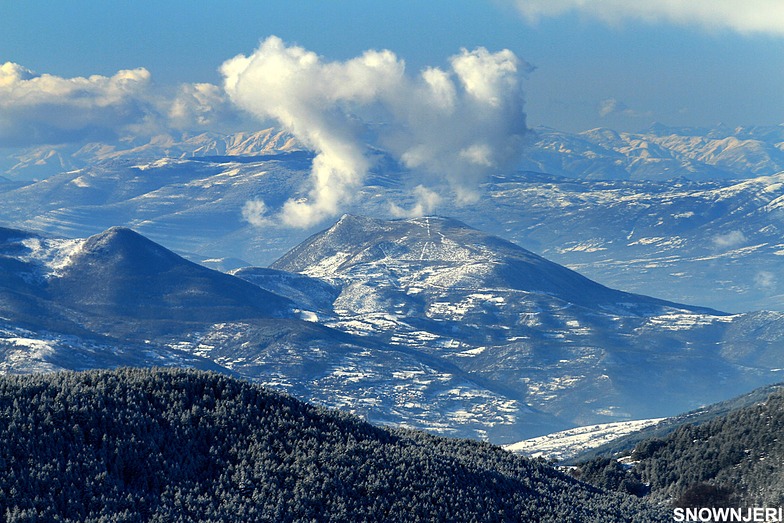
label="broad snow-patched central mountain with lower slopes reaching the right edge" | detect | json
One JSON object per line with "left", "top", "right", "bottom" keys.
{"left": 273, "top": 216, "right": 784, "bottom": 432}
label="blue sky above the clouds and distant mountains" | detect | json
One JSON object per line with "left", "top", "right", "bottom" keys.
{"left": 0, "top": 0, "right": 784, "bottom": 135}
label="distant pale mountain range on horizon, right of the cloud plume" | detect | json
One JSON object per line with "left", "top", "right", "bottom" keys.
{"left": 520, "top": 125, "right": 784, "bottom": 180}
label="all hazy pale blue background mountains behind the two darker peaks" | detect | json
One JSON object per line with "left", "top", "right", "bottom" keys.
{"left": 0, "top": 126, "right": 784, "bottom": 312}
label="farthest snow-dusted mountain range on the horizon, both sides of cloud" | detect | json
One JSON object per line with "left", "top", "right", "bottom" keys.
{"left": 7, "top": 123, "right": 784, "bottom": 180}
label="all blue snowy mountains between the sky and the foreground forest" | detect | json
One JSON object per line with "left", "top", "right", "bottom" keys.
{"left": 0, "top": 126, "right": 784, "bottom": 443}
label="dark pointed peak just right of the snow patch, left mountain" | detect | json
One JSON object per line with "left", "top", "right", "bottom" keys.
{"left": 47, "top": 227, "right": 294, "bottom": 322}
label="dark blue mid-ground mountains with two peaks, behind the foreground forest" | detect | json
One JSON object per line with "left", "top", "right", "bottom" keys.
{"left": 0, "top": 215, "right": 784, "bottom": 443}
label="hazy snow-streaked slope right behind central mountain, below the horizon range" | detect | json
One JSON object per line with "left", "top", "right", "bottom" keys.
{"left": 461, "top": 173, "right": 784, "bottom": 311}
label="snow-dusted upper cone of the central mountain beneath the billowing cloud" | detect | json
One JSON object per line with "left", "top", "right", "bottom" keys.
{"left": 272, "top": 215, "right": 716, "bottom": 315}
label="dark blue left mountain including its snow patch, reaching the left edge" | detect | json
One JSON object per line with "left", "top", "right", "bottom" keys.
{"left": 0, "top": 227, "right": 297, "bottom": 343}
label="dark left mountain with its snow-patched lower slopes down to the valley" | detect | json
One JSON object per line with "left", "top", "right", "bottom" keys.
{"left": 0, "top": 228, "right": 569, "bottom": 438}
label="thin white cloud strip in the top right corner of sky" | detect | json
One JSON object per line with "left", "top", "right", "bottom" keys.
{"left": 513, "top": 0, "right": 784, "bottom": 36}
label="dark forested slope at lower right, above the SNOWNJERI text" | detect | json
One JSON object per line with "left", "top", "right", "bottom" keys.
{"left": 575, "top": 390, "right": 784, "bottom": 507}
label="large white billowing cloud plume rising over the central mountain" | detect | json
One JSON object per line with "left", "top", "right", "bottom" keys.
{"left": 221, "top": 36, "right": 527, "bottom": 227}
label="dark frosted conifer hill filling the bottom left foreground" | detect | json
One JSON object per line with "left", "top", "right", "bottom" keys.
{"left": 0, "top": 369, "right": 671, "bottom": 522}
